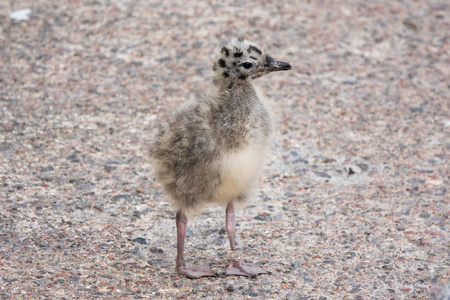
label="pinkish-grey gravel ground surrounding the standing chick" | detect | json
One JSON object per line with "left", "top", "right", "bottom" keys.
{"left": 0, "top": 0, "right": 450, "bottom": 300}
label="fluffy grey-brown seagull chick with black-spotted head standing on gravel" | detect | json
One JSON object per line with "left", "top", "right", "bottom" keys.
{"left": 150, "top": 39, "right": 292, "bottom": 278}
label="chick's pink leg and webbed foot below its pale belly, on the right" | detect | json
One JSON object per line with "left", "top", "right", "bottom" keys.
{"left": 225, "top": 202, "right": 270, "bottom": 277}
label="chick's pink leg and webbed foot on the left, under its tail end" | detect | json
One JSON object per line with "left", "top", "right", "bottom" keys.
{"left": 175, "top": 210, "right": 217, "bottom": 279}
